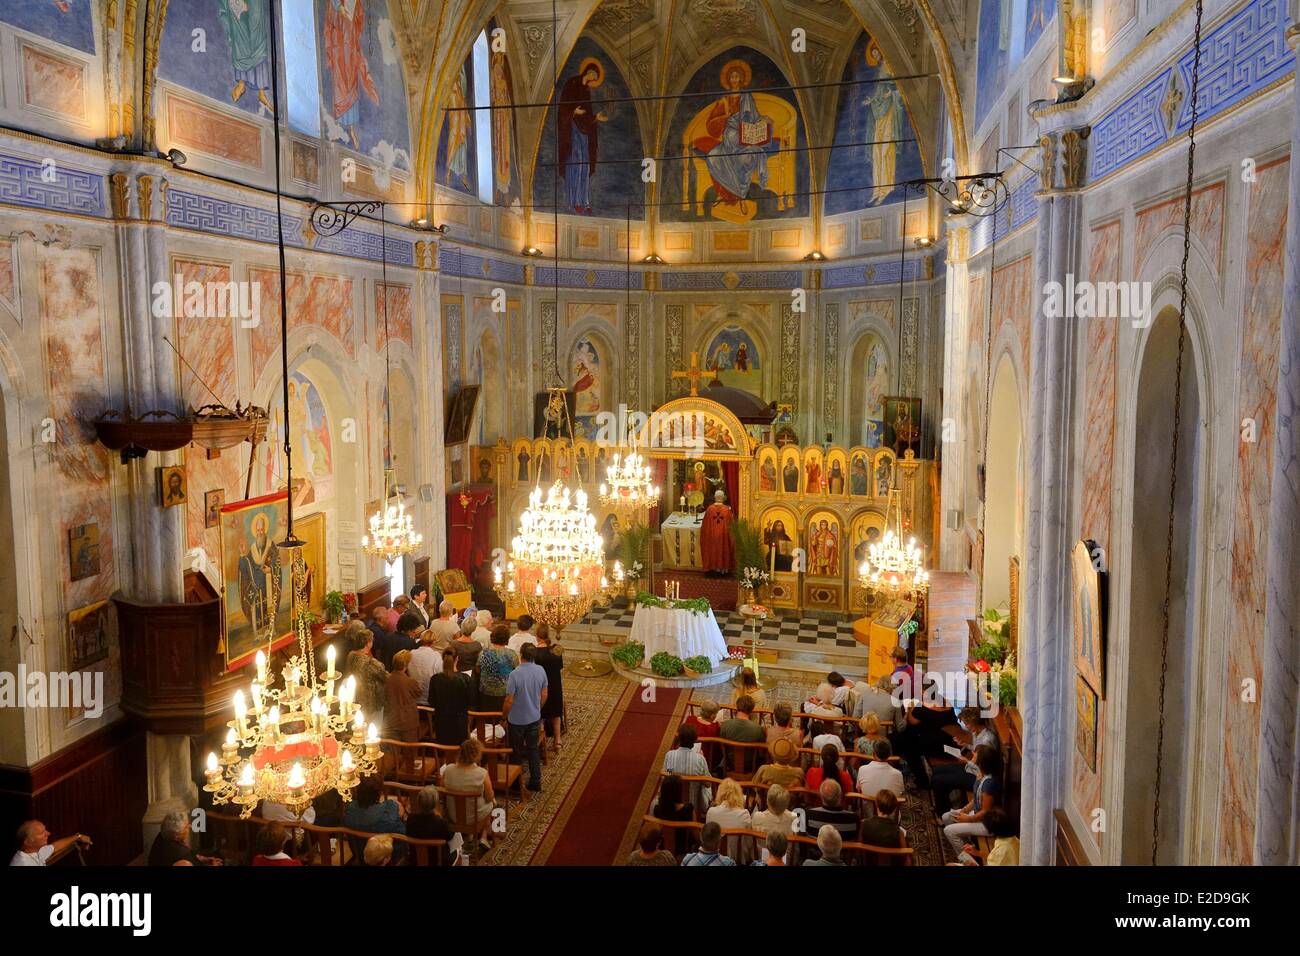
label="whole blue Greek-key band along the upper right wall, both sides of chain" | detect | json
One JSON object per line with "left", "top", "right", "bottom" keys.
{"left": 1088, "top": 0, "right": 1296, "bottom": 181}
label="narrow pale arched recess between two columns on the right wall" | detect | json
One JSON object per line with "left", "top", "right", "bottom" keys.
{"left": 978, "top": 354, "right": 1024, "bottom": 610}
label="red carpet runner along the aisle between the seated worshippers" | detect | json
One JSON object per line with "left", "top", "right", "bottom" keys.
{"left": 532, "top": 685, "right": 683, "bottom": 866}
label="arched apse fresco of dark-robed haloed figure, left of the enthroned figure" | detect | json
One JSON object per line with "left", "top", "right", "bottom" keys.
{"left": 533, "top": 36, "right": 645, "bottom": 220}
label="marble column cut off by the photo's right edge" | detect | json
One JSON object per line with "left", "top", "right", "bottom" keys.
{"left": 1255, "top": 26, "right": 1300, "bottom": 866}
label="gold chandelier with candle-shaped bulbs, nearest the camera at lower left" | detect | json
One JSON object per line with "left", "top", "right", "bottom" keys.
{"left": 203, "top": 541, "right": 380, "bottom": 818}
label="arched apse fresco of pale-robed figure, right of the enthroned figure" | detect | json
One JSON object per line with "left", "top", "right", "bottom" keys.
{"left": 826, "top": 33, "right": 926, "bottom": 215}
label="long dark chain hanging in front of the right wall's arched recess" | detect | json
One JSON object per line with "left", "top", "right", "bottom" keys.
{"left": 1151, "top": 0, "right": 1203, "bottom": 866}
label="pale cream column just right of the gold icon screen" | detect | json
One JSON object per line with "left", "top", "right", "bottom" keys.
{"left": 935, "top": 220, "right": 971, "bottom": 571}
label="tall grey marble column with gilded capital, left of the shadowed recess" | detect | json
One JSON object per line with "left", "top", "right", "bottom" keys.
{"left": 1019, "top": 131, "right": 1086, "bottom": 866}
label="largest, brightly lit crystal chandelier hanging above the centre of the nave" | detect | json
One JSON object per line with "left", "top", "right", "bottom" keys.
{"left": 493, "top": 481, "right": 624, "bottom": 631}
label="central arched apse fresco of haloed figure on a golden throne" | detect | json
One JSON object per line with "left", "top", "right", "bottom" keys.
{"left": 660, "top": 47, "right": 809, "bottom": 225}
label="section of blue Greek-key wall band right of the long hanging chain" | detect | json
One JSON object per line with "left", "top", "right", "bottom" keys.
{"left": 1177, "top": 0, "right": 1296, "bottom": 133}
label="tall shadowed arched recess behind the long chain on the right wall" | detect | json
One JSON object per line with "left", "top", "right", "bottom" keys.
{"left": 1119, "top": 308, "right": 1205, "bottom": 865}
